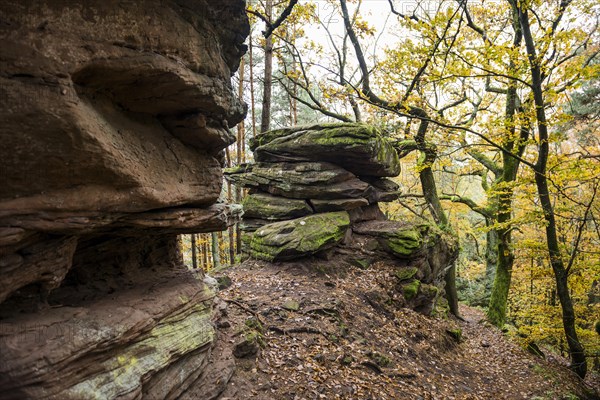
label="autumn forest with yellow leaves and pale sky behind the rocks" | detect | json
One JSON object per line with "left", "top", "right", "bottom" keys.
{"left": 181, "top": 0, "right": 600, "bottom": 376}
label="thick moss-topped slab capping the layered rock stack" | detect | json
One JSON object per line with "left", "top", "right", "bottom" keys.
{"left": 252, "top": 123, "right": 400, "bottom": 176}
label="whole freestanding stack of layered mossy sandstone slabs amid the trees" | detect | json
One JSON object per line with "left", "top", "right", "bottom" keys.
{"left": 225, "top": 123, "right": 456, "bottom": 314}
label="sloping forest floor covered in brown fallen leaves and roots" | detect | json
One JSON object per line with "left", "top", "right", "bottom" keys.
{"left": 209, "top": 260, "right": 600, "bottom": 400}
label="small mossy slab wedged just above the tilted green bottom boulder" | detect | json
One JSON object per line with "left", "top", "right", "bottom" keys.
{"left": 242, "top": 193, "right": 313, "bottom": 220}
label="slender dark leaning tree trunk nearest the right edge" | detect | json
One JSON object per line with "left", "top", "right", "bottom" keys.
{"left": 519, "top": 8, "right": 587, "bottom": 379}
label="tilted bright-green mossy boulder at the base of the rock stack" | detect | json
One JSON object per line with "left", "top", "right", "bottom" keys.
{"left": 250, "top": 211, "right": 350, "bottom": 261}
